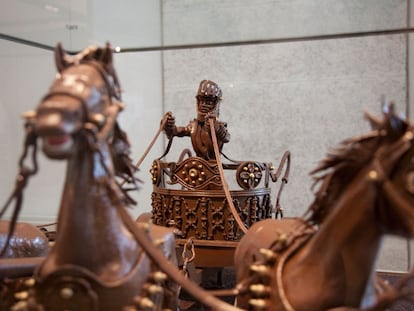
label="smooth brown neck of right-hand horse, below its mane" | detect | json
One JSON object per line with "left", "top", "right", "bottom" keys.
{"left": 289, "top": 169, "right": 382, "bottom": 303}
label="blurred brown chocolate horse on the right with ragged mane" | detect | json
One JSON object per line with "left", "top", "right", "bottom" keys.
{"left": 235, "top": 106, "right": 414, "bottom": 311}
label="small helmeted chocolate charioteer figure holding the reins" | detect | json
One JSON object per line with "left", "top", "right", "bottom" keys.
{"left": 163, "top": 80, "right": 230, "bottom": 160}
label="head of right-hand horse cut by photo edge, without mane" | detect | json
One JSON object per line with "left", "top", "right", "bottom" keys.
{"left": 368, "top": 105, "right": 414, "bottom": 238}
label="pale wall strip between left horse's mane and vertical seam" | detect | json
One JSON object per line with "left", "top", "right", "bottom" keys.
{"left": 115, "top": 52, "right": 163, "bottom": 216}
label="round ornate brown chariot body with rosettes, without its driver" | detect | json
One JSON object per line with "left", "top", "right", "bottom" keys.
{"left": 151, "top": 157, "right": 286, "bottom": 267}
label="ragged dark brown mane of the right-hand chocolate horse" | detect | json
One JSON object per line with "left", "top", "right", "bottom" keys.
{"left": 304, "top": 103, "right": 408, "bottom": 225}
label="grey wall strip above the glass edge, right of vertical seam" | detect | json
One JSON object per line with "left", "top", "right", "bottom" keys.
{"left": 162, "top": 0, "right": 407, "bottom": 45}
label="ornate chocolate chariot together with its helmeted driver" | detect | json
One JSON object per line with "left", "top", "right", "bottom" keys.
{"left": 151, "top": 80, "right": 290, "bottom": 267}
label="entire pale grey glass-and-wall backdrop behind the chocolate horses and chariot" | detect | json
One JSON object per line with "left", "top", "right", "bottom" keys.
{"left": 0, "top": 0, "right": 414, "bottom": 270}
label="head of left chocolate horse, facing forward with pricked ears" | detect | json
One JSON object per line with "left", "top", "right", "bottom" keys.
{"left": 35, "top": 45, "right": 120, "bottom": 159}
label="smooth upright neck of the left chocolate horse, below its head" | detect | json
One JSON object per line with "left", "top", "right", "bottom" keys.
{"left": 53, "top": 140, "right": 136, "bottom": 273}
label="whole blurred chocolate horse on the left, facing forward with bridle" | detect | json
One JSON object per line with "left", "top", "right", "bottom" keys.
{"left": 1, "top": 45, "right": 241, "bottom": 311}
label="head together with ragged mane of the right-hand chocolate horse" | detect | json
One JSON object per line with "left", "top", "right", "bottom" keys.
{"left": 305, "top": 104, "right": 414, "bottom": 236}
